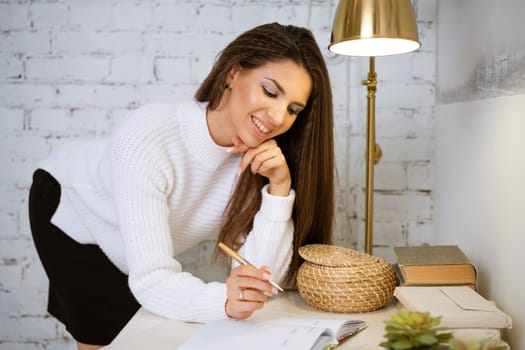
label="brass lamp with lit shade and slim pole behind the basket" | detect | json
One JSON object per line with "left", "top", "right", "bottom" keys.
{"left": 328, "top": 0, "right": 421, "bottom": 254}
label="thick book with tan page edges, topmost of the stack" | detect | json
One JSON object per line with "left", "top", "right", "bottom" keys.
{"left": 394, "top": 245, "right": 477, "bottom": 290}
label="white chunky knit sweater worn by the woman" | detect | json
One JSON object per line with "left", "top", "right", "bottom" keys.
{"left": 41, "top": 101, "right": 295, "bottom": 322}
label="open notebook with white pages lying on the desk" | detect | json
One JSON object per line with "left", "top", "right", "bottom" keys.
{"left": 179, "top": 314, "right": 366, "bottom": 350}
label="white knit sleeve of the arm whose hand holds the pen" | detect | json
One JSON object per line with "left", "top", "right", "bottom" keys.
{"left": 110, "top": 106, "right": 227, "bottom": 322}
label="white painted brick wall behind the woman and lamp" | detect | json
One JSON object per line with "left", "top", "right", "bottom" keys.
{"left": 0, "top": 0, "right": 436, "bottom": 350}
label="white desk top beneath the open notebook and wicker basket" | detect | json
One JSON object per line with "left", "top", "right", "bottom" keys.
{"left": 104, "top": 292, "right": 396, "bottom": 350}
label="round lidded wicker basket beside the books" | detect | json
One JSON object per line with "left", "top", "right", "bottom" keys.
{"left": 297, "top": 244, "right": 396, "bottom": 312}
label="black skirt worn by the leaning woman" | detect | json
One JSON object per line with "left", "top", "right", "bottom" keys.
{"left": 29, "top": 169, "right": 140, "bottom": 345}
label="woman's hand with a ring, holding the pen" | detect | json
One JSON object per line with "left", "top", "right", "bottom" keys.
{"left": 224, "top": 265, "right": 277, "bottom": 319}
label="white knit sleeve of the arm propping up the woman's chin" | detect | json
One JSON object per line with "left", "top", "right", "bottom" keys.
{"left": 239, "top": 185, "right": 295, "bottom": 281}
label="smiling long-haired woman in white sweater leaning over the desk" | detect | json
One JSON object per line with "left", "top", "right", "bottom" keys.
{"left": 29, "top": 23, "right": 334, "bottom": 349}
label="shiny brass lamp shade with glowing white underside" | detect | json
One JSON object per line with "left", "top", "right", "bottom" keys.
{"left": 328, "top": 0, "right": 421, "bottom": 56}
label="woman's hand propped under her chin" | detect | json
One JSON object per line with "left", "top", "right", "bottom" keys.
{"left": 230, "top": 137, "right": 292, "bottom": 196}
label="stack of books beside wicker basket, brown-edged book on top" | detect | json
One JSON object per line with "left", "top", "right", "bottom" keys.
{"left": 394, "top": 245, "right": 512, "bottom": 345}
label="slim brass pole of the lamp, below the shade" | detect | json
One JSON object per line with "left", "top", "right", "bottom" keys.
{"left": 361, "top": 56, "right": 382, "bottom": 255}
